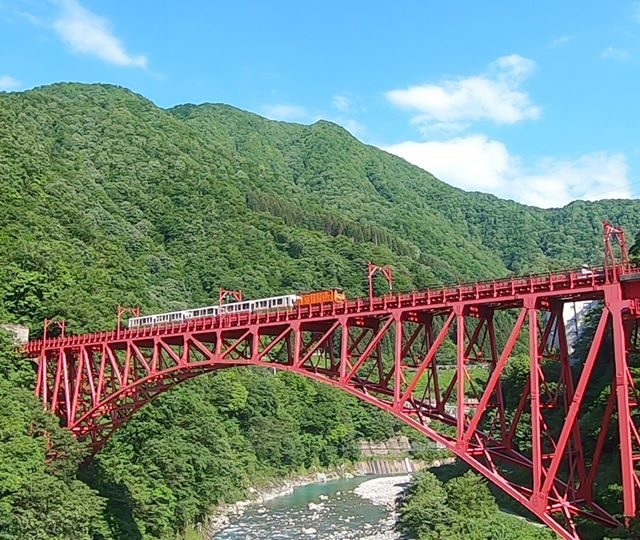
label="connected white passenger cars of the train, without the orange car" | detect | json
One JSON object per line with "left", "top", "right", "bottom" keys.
{"left": 128, "top": 294, "right": 300, "bottom": 328}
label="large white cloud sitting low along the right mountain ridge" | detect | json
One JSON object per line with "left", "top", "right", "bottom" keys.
{"left": 385, "top": 135, "right": 632, "bottom": 208}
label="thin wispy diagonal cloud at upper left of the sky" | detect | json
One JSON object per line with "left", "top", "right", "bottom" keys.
{"left": 53, "top": 0, "right": 147, "bottom": 68}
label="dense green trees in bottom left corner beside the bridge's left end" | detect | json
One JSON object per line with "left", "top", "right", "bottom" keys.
{"left": 0, "top": 333, "right": 111, "bottom": 540}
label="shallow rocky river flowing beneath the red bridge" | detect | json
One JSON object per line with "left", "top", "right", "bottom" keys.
{"left": 212, "top": 476, "right": 409, "bottom": 540}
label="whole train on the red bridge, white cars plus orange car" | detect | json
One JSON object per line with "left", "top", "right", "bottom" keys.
{"left": 128, "top": 288, "right": 346, "bottom": 328}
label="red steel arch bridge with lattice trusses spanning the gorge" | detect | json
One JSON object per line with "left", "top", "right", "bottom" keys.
{"left": 26, "top": 225, "right": 640, "bottom": 539}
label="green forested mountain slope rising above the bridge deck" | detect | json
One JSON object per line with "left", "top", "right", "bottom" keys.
{"left": 0, "top": 84, "right": 640, "bottom": 330}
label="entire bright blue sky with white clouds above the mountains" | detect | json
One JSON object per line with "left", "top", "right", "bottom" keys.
{"left": 0, "top": 0, "right": 640, "bottom": 206}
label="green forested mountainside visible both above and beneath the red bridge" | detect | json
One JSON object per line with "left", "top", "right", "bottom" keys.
{"left": 0, "top": 84, "right": 640, "bottom": 539}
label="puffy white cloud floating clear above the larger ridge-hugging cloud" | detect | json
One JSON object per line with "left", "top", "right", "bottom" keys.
{"left": 386, "top": 54, "right": 541, "bottom": 131}
